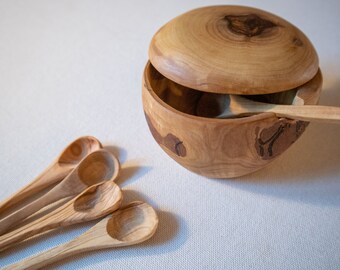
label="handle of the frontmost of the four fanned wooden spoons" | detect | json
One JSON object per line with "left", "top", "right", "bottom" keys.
{"left": 4, "top": 216, "right": 113, "bottom": 270}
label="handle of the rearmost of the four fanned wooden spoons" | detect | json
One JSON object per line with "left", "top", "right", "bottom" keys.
{"left": 0, "top": 163, "right": 73, "bottom": 215}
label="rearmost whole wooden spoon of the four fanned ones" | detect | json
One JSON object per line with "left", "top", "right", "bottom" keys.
{"left": 0, "top": 136, "right": 102, "bottom": 213}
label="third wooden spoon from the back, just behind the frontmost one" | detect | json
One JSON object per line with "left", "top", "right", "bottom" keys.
{"left": 0, "top": 181, "right": 122, "bottom": 250}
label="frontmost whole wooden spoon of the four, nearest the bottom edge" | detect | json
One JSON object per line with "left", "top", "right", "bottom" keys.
{"left": 4, "top": 202, "right": 158, "bottom": 270}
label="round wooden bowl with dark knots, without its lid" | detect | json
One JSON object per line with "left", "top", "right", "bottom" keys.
{"left": 143, "top": 64, "right": 322, "bottom": 178}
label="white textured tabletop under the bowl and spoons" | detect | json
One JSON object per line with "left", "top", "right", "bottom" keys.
{"left": 0, "top": 0, "right": 340, "bottom": 270}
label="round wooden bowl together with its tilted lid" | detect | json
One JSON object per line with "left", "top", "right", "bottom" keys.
{"left": 142, "top": 6, "right": 322, "bottom": 178}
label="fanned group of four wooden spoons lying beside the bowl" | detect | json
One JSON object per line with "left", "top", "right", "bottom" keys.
{"left": 0, "top": 136, "right": 158, "bottom": 269}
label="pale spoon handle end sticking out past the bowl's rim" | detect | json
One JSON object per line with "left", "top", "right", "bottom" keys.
{"left": 267, "top": 105, "right": 340, "bottom": 124}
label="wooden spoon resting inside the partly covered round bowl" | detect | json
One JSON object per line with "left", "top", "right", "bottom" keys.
{"left": 197, "top": 94, "right": 340, "bottom": 124}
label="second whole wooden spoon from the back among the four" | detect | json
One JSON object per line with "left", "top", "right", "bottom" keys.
{"left": 0, "top": 149, "right": 120, "bottom": 235}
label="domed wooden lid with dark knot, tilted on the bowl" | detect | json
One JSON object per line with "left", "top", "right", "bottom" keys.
{"left": 149, "top": 6, "right": 319, "bottom": 94}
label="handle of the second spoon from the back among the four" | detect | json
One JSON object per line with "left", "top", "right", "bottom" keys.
{"left": 0, "top": 184, "right": 70, "bottom": 235}
